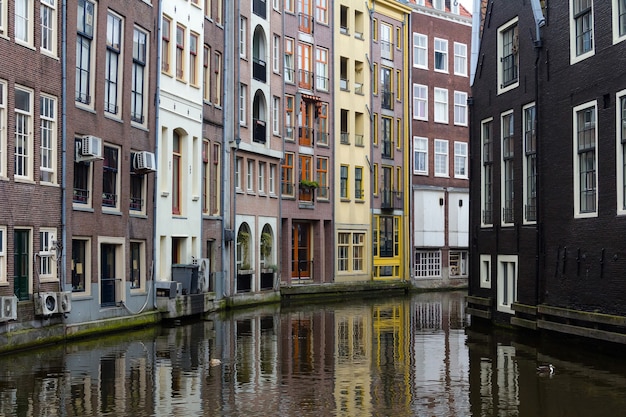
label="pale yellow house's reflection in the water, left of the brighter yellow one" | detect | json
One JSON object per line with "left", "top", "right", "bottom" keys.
{"left": 334, "top": 308, "right": 372, "bottom": 416}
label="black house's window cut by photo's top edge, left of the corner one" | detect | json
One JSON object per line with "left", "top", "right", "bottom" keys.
{"left": 570, "top": 0, "right": 594, "bottom": 59}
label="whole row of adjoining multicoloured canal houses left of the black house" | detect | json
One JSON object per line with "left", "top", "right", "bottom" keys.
{"left": 0, "top": 0, "right": 471, "bottom": 346}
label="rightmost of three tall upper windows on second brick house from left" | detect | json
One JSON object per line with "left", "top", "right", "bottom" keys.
{"left": 130, "top": 28, "right": 148, "bottom": 124}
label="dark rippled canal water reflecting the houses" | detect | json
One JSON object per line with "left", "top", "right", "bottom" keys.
{"left": 0, "top": 292, "right": 626, "bottom": 417}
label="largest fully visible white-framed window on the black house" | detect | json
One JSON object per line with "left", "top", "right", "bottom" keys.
{"left": 574, "top": 102, "right": 598, "bottom": 217}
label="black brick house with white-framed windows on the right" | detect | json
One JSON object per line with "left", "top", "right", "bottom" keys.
{"left": 468, "top": 0, "right": 626, "bottom": 342}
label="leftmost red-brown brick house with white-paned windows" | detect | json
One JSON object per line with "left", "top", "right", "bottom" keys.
{"left": 0, "top": 1, "right": 63, "bottom": 334}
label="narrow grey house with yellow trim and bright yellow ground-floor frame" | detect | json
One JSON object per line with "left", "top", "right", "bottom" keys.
{"left": 368, "top": 0, "right": 411, "bottom": 280}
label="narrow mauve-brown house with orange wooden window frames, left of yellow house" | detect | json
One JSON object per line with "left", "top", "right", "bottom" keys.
{"left": 280, "top": 0, "right": 338, "bottom": 284}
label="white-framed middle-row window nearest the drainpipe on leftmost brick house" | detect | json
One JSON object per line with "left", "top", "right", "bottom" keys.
{"left": 39, "top": 95, "right": 57, "bottom": 183}
